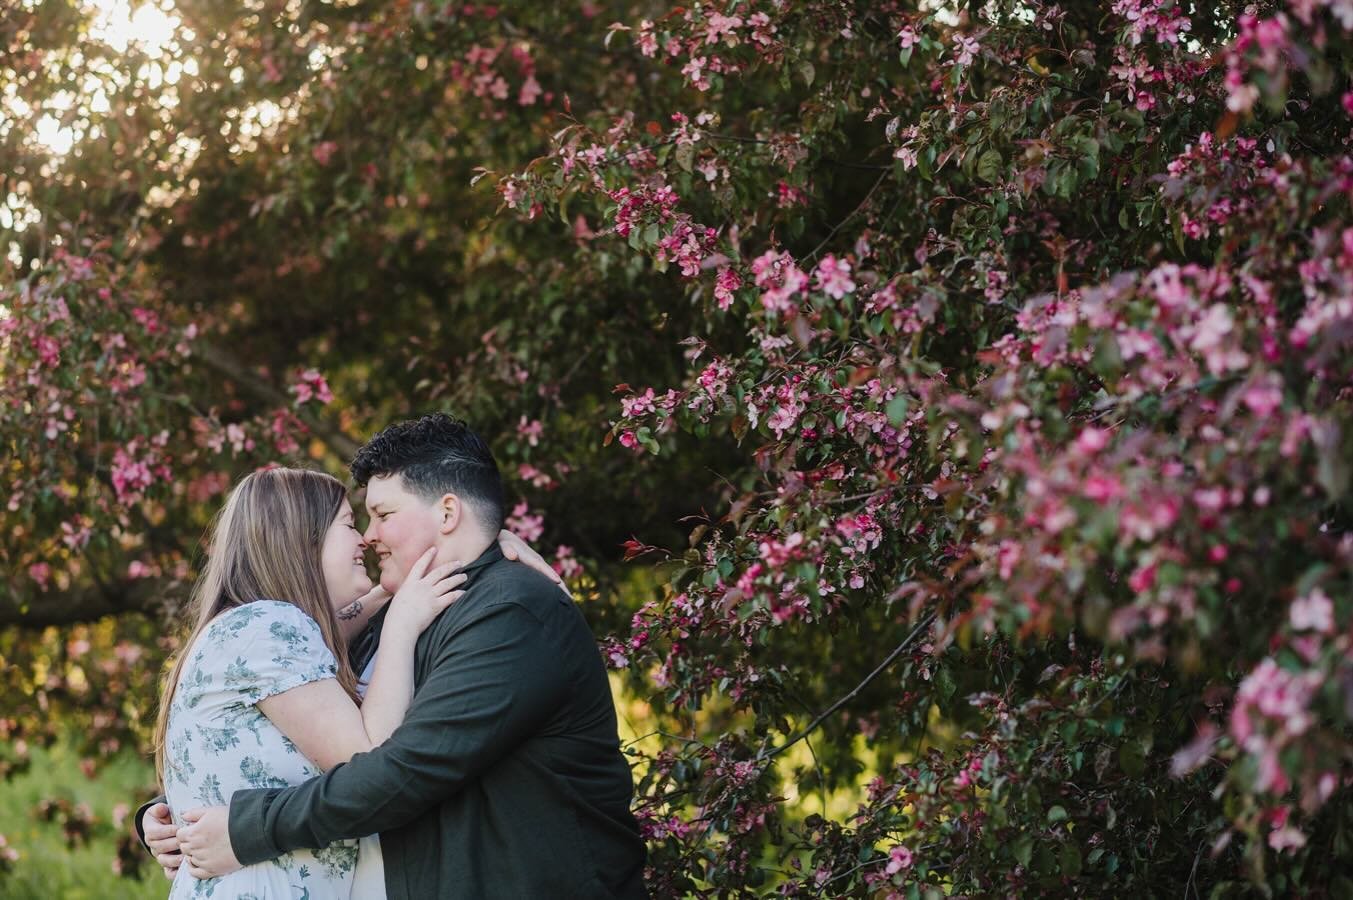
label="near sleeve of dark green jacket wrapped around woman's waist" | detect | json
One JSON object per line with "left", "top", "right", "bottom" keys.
{"left": 230, "top": 602, "right": 566, "bottom": 865}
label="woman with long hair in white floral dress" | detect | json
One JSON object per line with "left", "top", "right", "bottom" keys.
{"left": 156, "top": 468, "right": 465, "bottom": 900}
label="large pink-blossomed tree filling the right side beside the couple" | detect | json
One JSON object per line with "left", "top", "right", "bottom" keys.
{"left": 502, "top": 0, "right": 1353, "bottom": 896}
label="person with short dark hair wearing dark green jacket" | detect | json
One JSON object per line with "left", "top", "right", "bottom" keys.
{"left": 163, "top": 415, "right": 647, "bottom": 899}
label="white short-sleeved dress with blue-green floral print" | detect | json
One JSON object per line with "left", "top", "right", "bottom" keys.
{"left": 165, "top": 600, "right": 357, "bottom": 900}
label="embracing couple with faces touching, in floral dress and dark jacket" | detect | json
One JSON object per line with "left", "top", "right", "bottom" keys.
{"left": 137, "top": 415, "right": 645, "bottom": 900}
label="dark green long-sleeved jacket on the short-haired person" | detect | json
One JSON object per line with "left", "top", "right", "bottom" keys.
{"left": 230, "top": 544, "right": 645, "bottom": 900}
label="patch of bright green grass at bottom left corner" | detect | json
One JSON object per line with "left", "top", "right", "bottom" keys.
{"left": 0, "top": 744, "right": 169, "bottom": 900}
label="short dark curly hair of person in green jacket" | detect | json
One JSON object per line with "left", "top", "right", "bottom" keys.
{"left": 348, "top": 413, "right": 506, "bottom": 533}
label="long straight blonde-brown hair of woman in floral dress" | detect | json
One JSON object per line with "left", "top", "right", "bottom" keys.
{"left": 154, "top": 468, "right": 360, "bottom": 785}
